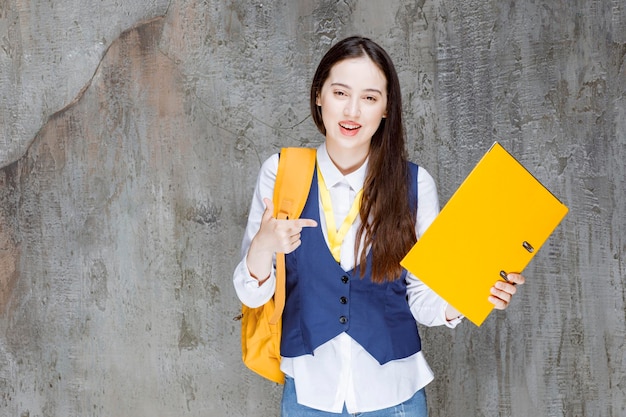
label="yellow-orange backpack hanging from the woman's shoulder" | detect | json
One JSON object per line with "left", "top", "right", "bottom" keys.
{"left": 239, "top": 148, "right": 316, "bottom": 384}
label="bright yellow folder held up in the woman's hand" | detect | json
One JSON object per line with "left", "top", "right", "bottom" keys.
{"left": 401, "top": 142, "right": 568, "bottom": 326}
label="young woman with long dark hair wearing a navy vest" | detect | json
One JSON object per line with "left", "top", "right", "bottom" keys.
{"left": 233, "top": 37, "right": 524, "bottom": 417}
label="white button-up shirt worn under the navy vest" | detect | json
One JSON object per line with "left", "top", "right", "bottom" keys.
{"left": 233, "top": 144, "right": 460, "bottom": 413}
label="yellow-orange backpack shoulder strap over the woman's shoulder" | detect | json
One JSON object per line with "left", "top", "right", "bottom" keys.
{"left": 270, "top": 148, "right": 317, "bottom": 324}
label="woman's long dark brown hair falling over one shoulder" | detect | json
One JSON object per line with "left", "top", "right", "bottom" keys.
{"left": 311, "top": 36, "right": 417, "bottom": 283}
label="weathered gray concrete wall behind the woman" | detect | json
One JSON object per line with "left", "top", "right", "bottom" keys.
{"left": 0, "top": 0, "right": 626, "bottom": 417}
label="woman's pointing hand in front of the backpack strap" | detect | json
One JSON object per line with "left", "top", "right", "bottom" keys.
{"left": 246, "top": 198, "right": 317, "bottom": 283}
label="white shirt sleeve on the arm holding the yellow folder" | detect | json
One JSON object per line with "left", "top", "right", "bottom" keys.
{"left": 407, "top": 167, "right": 461, "bottom": 328}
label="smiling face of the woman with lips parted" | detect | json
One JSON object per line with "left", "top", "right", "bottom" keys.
{"left": 316, "top": 55, "right": 387, "bottom": 156}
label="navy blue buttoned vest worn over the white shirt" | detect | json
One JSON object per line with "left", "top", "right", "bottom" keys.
{"left": 280, "top": 163, "right": 421, "bottom": 364}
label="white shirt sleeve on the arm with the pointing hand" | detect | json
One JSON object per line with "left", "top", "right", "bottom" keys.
{"left": 233, "top": 154, "right": 278, "bottom": 308}
